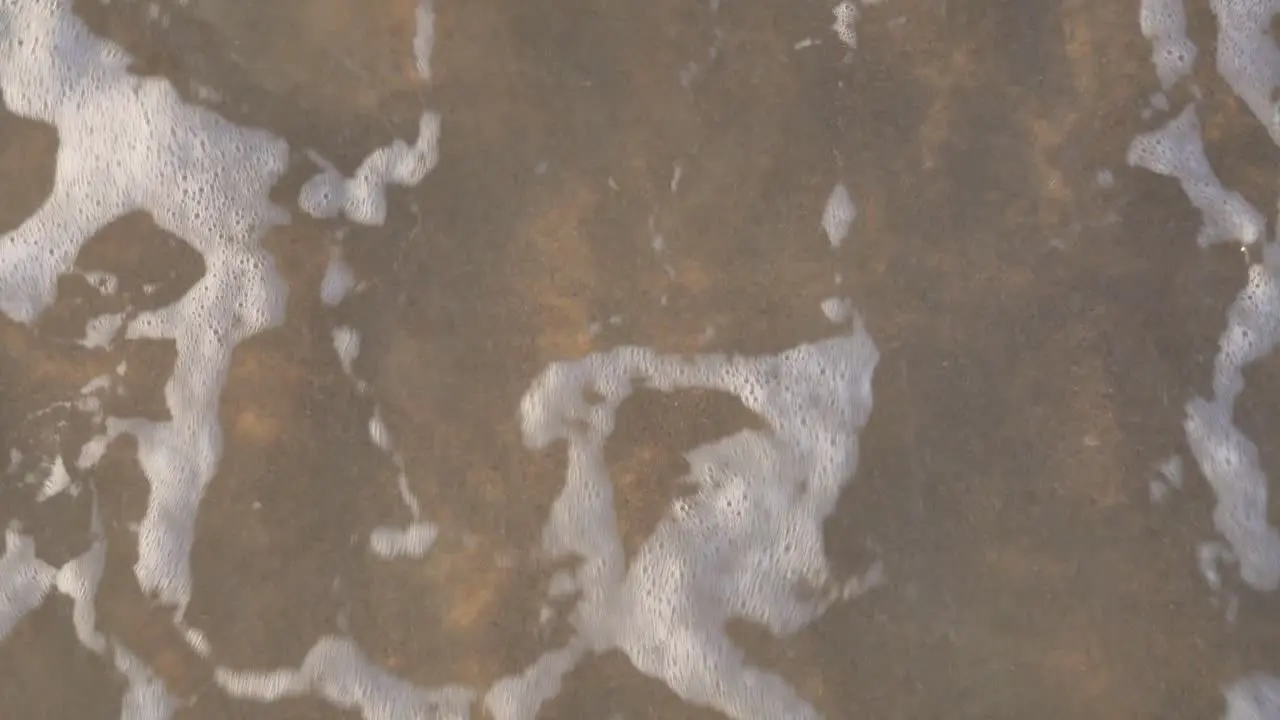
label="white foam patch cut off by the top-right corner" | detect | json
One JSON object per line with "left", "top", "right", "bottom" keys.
{"left": 1210, "top": 0, "right": 1280, "bottom": 145}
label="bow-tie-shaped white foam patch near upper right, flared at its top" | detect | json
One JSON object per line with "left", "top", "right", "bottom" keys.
{"left": 1128, "top": 105, "right": 1266, "bottom": 246}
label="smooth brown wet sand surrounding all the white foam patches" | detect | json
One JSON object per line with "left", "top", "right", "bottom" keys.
{"left": 0, "top": 0, "right": 1280, "bottom": 720}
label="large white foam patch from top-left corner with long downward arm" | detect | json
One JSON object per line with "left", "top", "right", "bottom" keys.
{"left": 0, "top": 0, "right": 288, "bottom": 610}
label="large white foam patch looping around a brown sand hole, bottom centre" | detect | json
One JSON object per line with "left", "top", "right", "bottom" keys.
{"left": 485, "top": 308, "right": 883, "bottom": 720}
